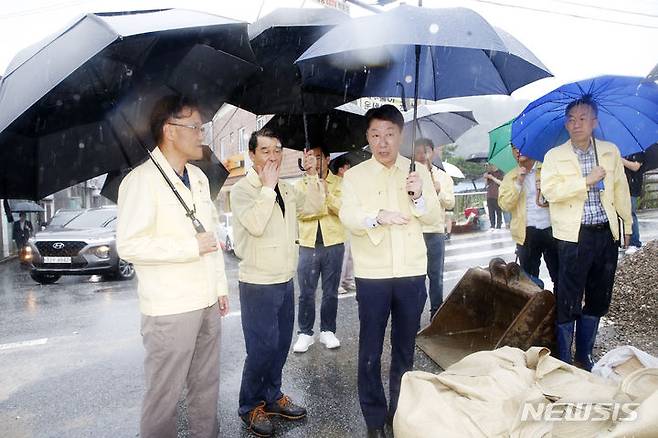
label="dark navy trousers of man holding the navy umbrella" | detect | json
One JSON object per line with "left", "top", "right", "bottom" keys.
{"left": 356, "top": 275, "right": 427, "bottom": 429}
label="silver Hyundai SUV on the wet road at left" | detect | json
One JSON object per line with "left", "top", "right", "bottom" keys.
{"left": 26, "top": 206, "right": 135, "bottom": 284}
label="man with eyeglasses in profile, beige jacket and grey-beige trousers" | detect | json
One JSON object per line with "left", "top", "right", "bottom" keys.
{"left": 117, "top": 96, "right": 229, "bottom": 438}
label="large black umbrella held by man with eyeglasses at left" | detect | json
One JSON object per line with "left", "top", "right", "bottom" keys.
{"left": 0, "top": 9, "right": 258, "bottom": 205}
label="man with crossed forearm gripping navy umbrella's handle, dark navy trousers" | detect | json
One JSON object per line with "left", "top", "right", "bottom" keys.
{"left": 340, "top": 105, "right": 439, "bottom": 437}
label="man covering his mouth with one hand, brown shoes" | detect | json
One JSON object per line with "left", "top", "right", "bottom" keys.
{"left": 231, "top": 129, "right": 325, "bottom": 436}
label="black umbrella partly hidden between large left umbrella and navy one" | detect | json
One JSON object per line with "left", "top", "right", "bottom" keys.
{"left": 229, "top": 8, "right": 350, "bottom": 114}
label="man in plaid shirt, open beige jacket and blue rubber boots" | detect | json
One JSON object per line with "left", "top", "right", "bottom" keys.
{"left": 541, "top": 96, "right": 632, "bottom": 370}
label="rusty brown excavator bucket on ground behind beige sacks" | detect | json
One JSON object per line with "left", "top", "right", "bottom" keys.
{"left": 416, "top": 258, "right": 555, "bottom": 369}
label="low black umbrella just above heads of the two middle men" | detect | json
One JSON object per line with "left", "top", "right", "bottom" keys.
{"left": 265, "top": 104, "right": 366, "bottom": 152}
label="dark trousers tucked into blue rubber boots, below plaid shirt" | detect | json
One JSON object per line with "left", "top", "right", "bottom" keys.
{"left": 555, "top": 226, "right": 618, "bottom": 324}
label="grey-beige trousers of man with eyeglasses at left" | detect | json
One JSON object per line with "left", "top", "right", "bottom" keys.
{"left": 140, "top": 304, "right": 220, "bottom": 438}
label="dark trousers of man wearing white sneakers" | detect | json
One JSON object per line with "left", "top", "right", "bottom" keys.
{"left": 297, "top": 243, "right": 345, "bottom": 336}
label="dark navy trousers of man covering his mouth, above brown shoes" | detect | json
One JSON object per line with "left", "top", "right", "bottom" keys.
{"left": 238, "top": 280, "right": 295, "bottom": 415}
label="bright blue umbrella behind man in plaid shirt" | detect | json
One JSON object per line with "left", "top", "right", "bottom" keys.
{"left": 512, "top": 76, "right": 658, "bottom": 161}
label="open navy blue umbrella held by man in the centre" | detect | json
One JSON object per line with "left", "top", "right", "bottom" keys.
{"left": 297, "top": 5, "right": 551, "bottom": 170}
